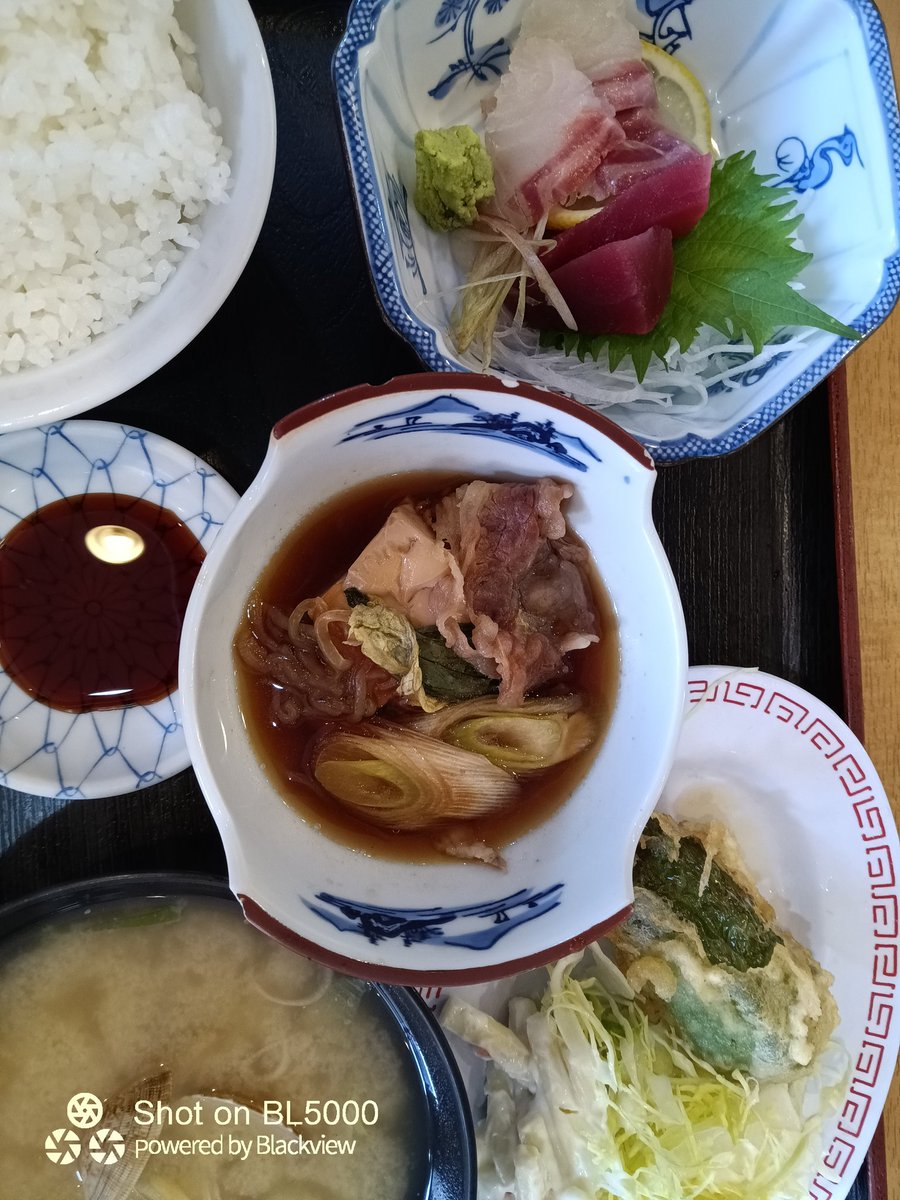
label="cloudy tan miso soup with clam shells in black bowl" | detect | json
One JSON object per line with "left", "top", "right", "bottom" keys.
{"left": 0, "top": 899, "right": 428, "bottom": 1200}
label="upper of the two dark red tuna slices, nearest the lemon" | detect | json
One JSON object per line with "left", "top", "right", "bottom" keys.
{"left": 541, "top": 151, "right": 713, "bottom": 275}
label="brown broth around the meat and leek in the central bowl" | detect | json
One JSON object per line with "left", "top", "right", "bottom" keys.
{"left": 234, "top": 472, "right": 619, "bottom": 862}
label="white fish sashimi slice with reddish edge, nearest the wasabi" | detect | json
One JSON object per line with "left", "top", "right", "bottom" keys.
{"left": 485, "top": 37, "right": 624, "bottom": 229}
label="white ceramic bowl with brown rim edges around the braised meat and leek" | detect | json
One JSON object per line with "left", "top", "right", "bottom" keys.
{"left": 180, "top": 373, "right": 686, "bottom": 984}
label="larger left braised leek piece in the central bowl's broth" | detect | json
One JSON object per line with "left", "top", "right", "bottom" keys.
{"left": 313, "top": 721, "right": 518, "bottom": 832}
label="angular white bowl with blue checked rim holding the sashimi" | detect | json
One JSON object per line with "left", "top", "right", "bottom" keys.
{"left": 334, "top": 0, "right": 900, "bottom": 461}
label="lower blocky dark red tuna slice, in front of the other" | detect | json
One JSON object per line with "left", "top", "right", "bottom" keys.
{"left": 526, "top": 226, "right": 673, "bottom": 334}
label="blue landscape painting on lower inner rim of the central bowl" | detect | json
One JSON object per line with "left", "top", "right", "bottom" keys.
{"left": 304, "top": 883, "right": 563, "bottom": 950}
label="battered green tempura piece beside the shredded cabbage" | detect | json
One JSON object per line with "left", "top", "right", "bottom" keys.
{"left": 610, "top": 814, "right": 838, "bottom": 1081}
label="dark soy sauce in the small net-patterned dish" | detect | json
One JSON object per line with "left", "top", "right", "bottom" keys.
{"left": 0, "top": 492, "right": 204, "bottom": 713}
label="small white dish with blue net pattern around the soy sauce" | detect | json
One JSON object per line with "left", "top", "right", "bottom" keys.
{"left": 0, "top": 421, "right": 238, "bottom": 799}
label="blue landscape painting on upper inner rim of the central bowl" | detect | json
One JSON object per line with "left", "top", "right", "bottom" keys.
{"left": 341, "top": 392, "right": 601, "bottom": 470}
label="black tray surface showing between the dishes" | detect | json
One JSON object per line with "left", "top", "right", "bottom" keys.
{"left": 0, "top": 0, "right": 868, "bottom": 1200}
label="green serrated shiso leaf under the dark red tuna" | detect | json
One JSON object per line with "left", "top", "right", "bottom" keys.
{"left": 541, "top": 151, "right": 860, "bottom": 382}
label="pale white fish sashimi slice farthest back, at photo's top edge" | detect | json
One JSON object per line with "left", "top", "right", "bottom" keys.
{"left": 520, "top": 0, "right": 641, "bottom": 80}
